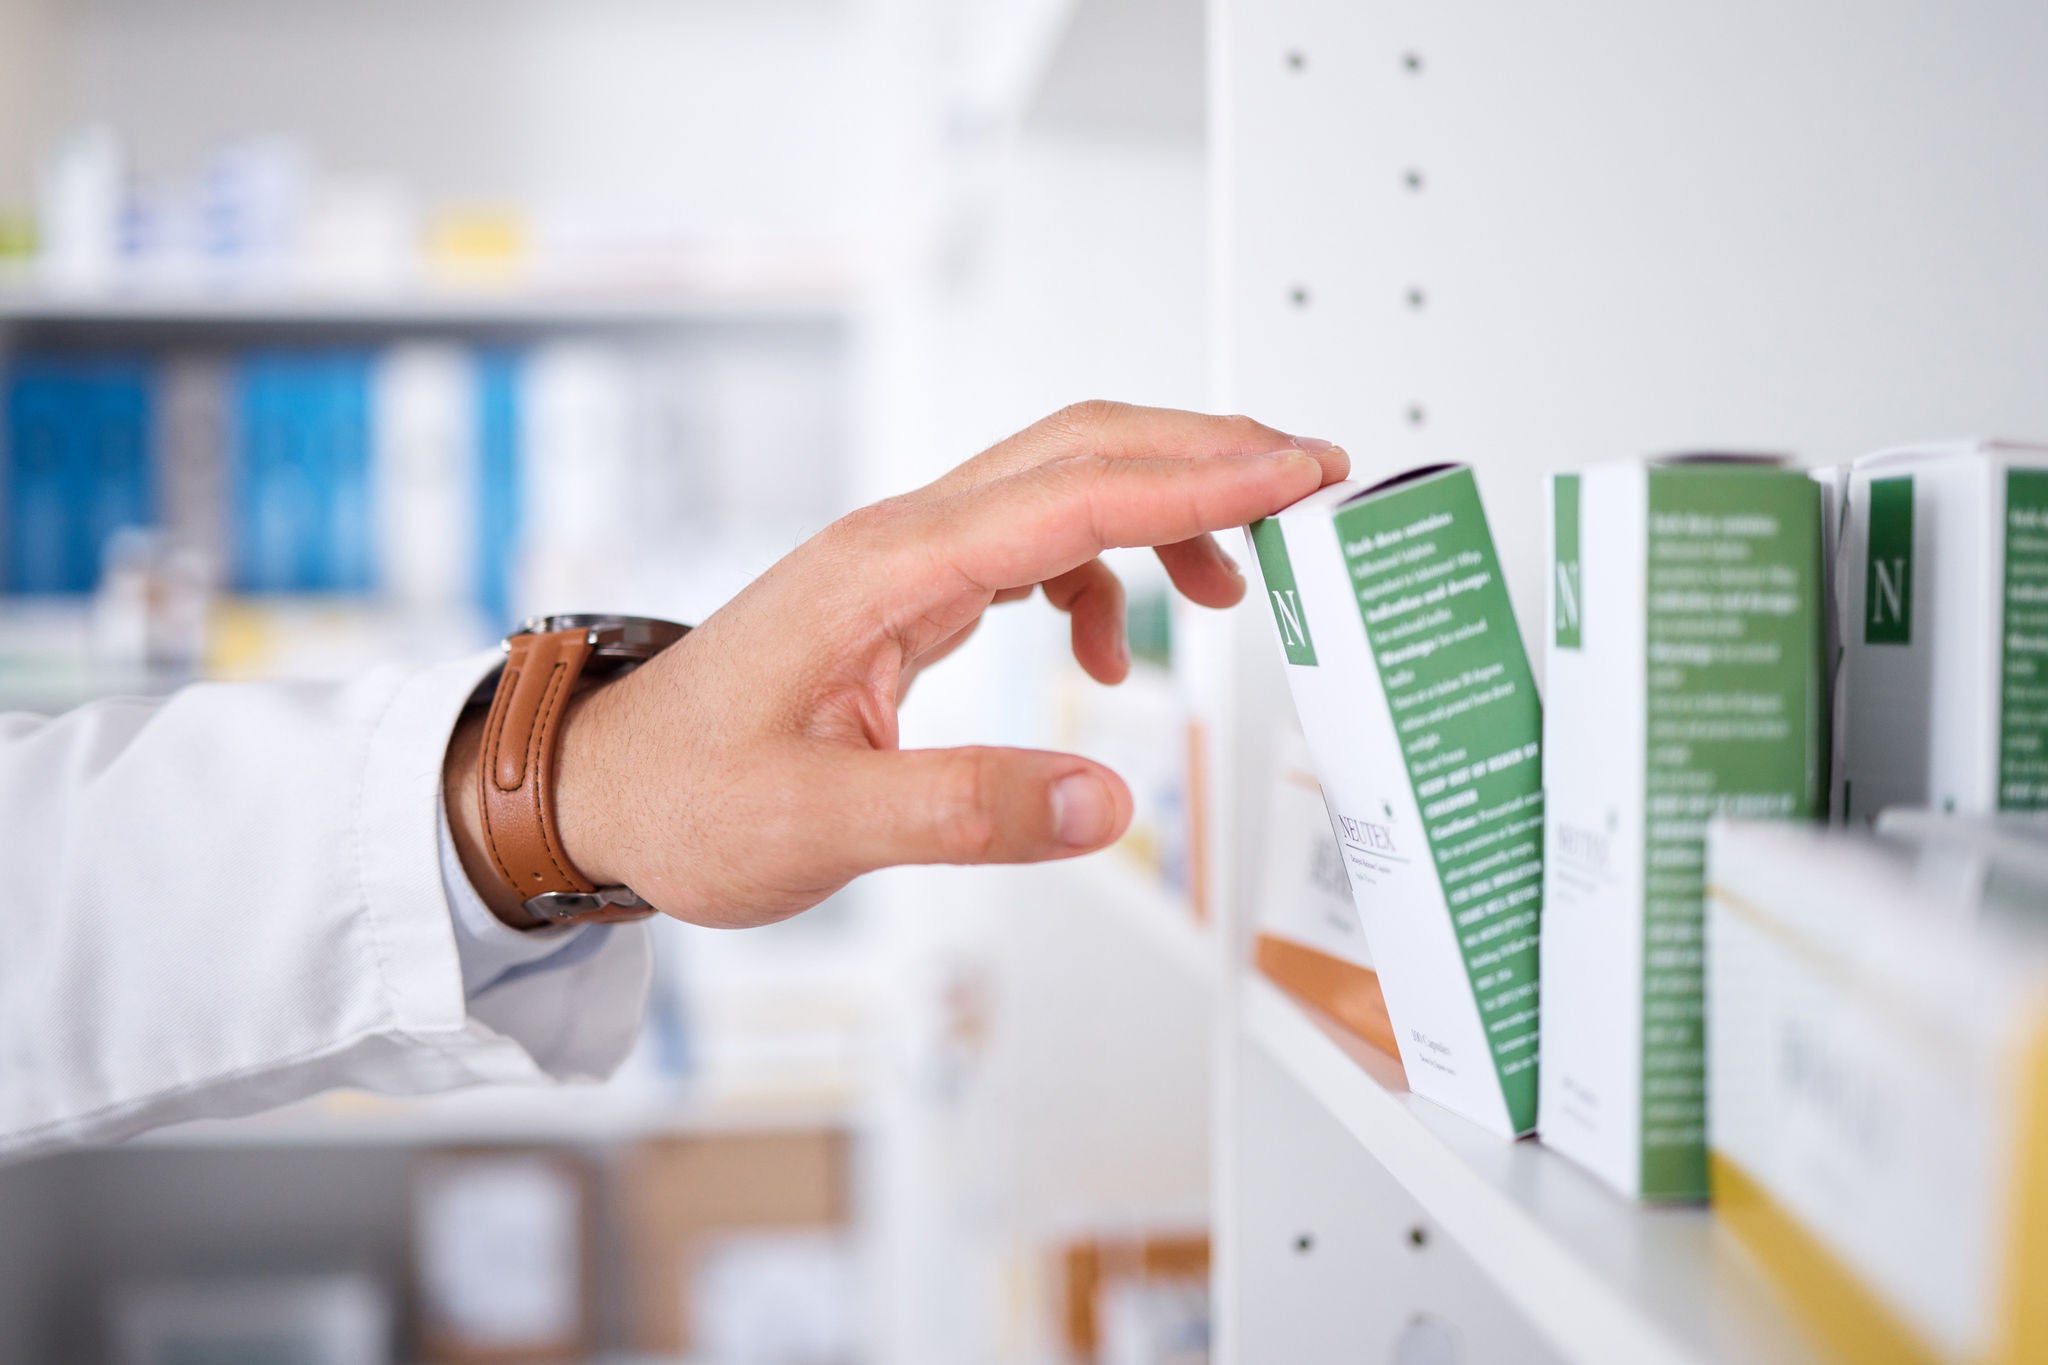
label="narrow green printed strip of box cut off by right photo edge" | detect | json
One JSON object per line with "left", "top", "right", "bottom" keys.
{"left": 1999, "top": 469, "right": 2048, "bottom": 810}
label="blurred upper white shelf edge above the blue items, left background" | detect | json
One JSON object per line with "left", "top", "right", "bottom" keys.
{"left": 0, "top": 284, "right": 850, "bottom": 327}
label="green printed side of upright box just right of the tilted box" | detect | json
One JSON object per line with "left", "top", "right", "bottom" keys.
{"left": 1642, "top": 467, "right": 1825, "bottom": 1199}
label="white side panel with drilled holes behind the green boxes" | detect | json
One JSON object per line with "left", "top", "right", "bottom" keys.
{"left": 1210, "top": 0, "right": 2048, "bottom": 1363}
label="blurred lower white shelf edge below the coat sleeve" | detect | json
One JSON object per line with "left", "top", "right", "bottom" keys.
{"left": 135, "top": 1087, "right": 858, "bottom": 1148}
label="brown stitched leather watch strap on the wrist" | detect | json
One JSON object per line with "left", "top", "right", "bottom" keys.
{"left": 477, "top": 630, "right": 596, "bottom": 925}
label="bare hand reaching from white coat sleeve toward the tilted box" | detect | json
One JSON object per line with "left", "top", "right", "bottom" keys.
{"left": 446, "top": 394, "right": 1350, "bottom": 927}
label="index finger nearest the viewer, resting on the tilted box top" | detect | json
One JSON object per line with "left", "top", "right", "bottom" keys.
{"left": 922, "top": 448, "right": 1325, "bottom": 591}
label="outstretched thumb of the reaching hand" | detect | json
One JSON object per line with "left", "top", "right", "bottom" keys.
{"left": 836, "top": 747, "right": 1130, "bottom": 872}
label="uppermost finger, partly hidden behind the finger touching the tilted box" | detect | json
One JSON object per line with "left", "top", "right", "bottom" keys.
{"left": 932, "top": 401, "right": 1352, "bottom": 491}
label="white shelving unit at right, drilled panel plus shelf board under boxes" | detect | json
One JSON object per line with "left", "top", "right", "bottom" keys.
{"left": 1194, "top": 0, "right": 2048, "bottom": 1365}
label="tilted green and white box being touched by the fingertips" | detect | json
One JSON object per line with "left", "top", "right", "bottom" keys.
{"left": 1249, "top": 465, "right": 1542, "bottom": 1136}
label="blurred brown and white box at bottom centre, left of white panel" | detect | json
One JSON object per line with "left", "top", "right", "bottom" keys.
{"left": 1059, "top": 1232, "right": 1210, "bottom": 1365}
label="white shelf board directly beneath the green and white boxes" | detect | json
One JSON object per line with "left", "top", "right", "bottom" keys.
{"left": 1241, "top": 974, "right": 1821, "bottom": 1365}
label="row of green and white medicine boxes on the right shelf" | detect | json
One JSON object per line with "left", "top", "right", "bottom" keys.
{"left": 1249, "top": 442, "right": 2048, "bottom": 1359}
